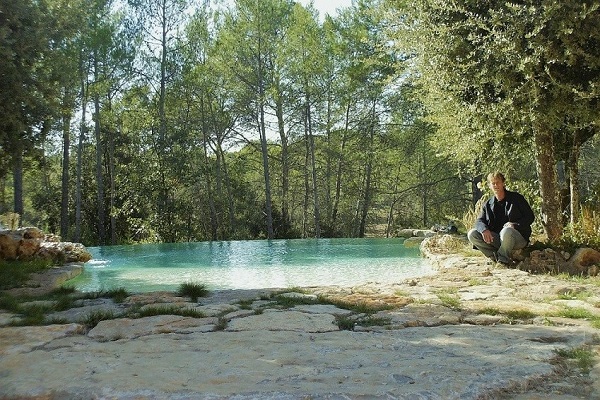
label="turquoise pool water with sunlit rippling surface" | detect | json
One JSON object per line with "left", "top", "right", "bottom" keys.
{"left": 72, "top": 239, "right": 431, "bottom": 292}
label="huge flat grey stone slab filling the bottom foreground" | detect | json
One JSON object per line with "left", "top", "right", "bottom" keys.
{"left": 0, "top": 324, "right": 592, "bottom": 399}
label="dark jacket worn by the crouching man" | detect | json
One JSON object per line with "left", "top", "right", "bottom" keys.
{"left": 475, "top": 190, "right": 535, "bottom": 241}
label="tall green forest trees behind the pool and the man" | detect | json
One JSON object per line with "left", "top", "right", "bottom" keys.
{"left": 0, "top": 0, "right": 600, "bottom": 246}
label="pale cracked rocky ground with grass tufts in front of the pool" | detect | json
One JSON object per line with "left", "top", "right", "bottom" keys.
{"left": 0, "top": 239, "right": 600, "bottom": 400}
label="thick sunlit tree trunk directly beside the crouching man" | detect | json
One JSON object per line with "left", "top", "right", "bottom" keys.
{"left": 534, "top": 128, "right": 563, "bottom": 242}
